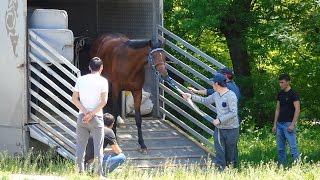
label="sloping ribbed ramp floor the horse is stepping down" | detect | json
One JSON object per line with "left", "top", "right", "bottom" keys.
{"left": 117, "top": 117, "right": 212, "bottom": 168}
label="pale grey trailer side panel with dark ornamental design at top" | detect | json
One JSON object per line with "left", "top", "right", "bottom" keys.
{"left": 0, "top": 0, "right": 28, "bottom": 154}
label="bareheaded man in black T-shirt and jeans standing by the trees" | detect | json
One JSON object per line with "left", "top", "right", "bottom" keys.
{"left": 272, "top": 74, "right": 300, "bottom": 164}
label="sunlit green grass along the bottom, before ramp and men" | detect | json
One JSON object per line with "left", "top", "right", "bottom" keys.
{"left": 0, "top": 123, "right": 320, "bottom": 180}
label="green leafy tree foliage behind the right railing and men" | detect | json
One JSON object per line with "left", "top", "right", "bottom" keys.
{"left": 164, "top": 0, "right": 320, "bottom": 126}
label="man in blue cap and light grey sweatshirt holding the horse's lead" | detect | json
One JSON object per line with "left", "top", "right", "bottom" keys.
{"left": 182, "top": 73, "right": 239, "bottom": 169}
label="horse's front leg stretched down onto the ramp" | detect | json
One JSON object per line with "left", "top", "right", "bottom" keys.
{"left": 132, "top": 89, "right": 147, "bottom": 154}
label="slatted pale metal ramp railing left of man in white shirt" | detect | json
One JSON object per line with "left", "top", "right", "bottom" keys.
{"left": 28, "top": 29, "right": 80, "bottom": 159}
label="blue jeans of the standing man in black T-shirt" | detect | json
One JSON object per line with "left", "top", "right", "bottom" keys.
{"left": 277, "top": 122, "right": 299, "bottom": 164}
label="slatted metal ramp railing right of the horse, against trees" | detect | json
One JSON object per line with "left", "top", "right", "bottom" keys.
{"left": 157, "top": 25, "right": 225, "bottom": 149}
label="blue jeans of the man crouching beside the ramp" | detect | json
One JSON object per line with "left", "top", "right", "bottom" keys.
{"left": 102, "top": 153, "right": 126, "bottom": 174}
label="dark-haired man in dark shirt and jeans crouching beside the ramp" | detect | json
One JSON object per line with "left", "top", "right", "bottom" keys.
{"left": 85, "top": 113, "right": 126, "bottom": 174}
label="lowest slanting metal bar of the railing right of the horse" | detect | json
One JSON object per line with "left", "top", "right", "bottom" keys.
{"left": 160, "top": 107, "right": 214, "bottom": 148}
